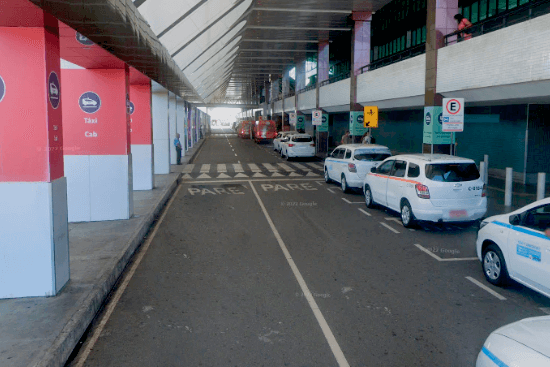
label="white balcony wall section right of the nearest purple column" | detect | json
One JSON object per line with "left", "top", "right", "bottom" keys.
{"left": 437, "top": 15, "right": 550, "bottom": 102}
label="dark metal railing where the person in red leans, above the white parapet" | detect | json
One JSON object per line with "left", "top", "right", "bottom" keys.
{"left": 445, "top": 0, "right": 550, "bottom": 46}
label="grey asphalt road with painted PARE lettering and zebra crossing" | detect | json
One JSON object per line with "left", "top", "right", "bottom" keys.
{"left": 71, "top": 129, "right": 550, "bottom": 367}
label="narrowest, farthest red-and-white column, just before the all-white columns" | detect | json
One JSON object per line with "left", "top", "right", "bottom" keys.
{"left": 130, "top": 75, "right": 155, "bottom": 190}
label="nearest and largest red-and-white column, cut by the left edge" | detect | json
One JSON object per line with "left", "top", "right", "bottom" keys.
{"left": 0, "top": 7, "right": 69, "bottom": 298}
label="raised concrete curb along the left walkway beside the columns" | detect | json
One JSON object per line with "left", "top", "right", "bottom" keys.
{"left": 30, "top": 174, "right": 182, "bottom": 367}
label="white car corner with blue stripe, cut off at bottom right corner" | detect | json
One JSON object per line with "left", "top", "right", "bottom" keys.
{"left": 476, "top": 316, "right": 550, "bottom": 367}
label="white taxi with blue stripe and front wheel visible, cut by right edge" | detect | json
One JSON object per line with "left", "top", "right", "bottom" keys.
{"left": 476, "top": 198, "right": 550, "bottom": 297}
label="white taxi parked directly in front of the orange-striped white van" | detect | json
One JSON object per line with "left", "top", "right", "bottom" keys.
{"left": 324, "top": 144, "right": 391, "bottom": 192}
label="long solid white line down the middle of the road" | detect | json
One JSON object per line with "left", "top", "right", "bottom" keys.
{"left": 248, "top": 181, "right": 349, "bottom": 367}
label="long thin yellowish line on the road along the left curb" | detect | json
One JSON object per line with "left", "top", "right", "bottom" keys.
{"left": 75, "top": 183, "right": 183, "bottom": 367}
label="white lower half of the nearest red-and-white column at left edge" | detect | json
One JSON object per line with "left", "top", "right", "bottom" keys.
{"left": 0, "top": 177, "right": 70, "bottom": 298}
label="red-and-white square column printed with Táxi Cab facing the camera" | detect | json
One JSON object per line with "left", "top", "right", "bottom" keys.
{"left": 61, "top": 65, "right": 134, "bottom": 222}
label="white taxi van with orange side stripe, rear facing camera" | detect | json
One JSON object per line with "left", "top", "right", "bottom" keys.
{"left": 363, "top": 154, "right": 487, "bottom": 227}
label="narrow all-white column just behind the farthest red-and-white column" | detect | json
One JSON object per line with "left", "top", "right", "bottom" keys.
{"left": 151, "top": 82, "right": 171, "bottom": 175}
